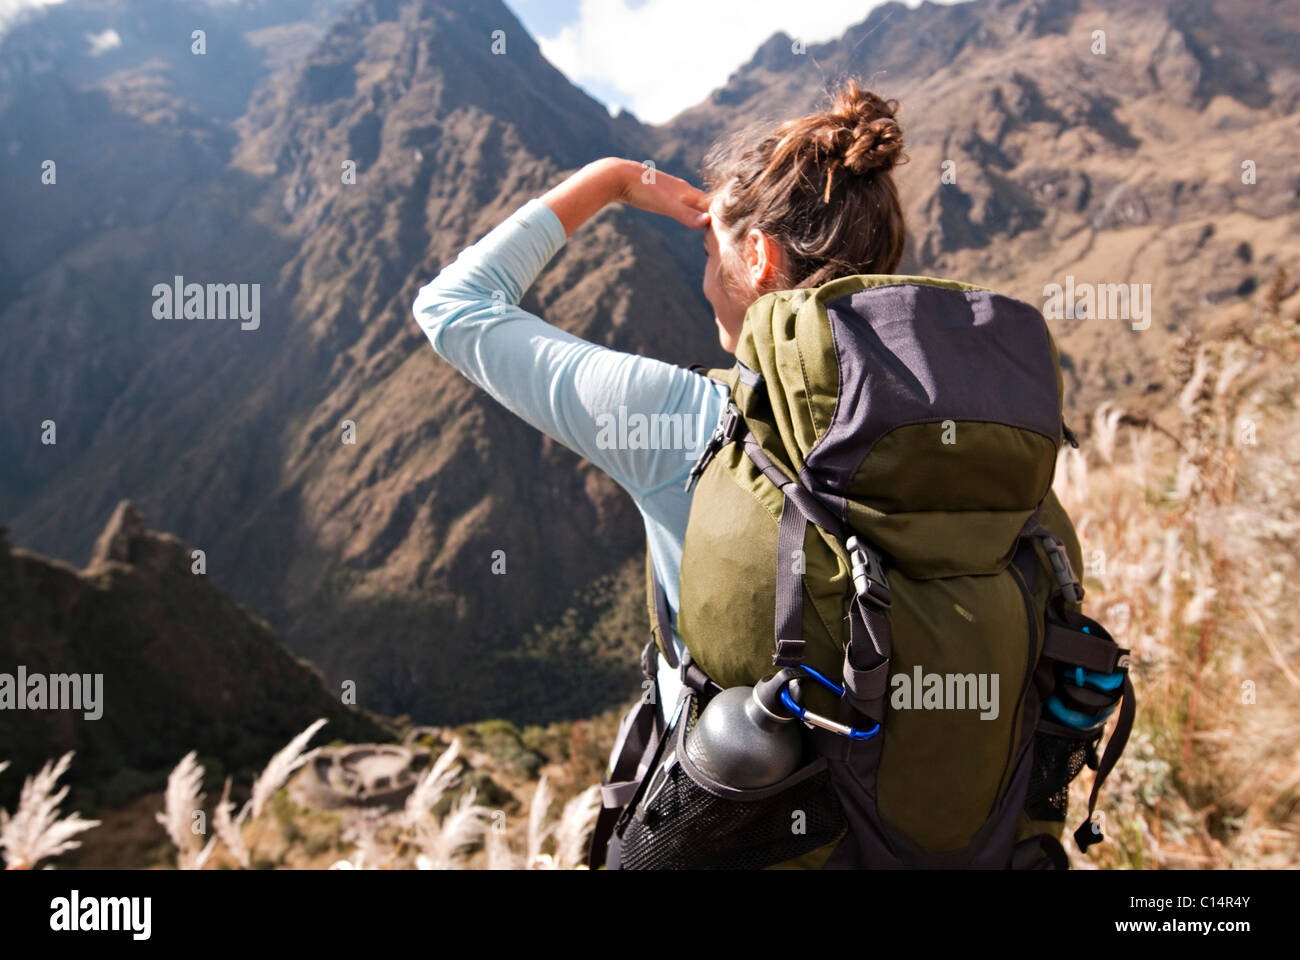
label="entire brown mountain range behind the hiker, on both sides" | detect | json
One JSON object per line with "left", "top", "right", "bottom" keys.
{"left": 0, "top": 0, "right": 1300, "bottom": 723}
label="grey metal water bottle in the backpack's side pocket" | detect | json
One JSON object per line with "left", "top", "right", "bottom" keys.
{"left": 686, "top": 676, "right": 803, "bottom": 790}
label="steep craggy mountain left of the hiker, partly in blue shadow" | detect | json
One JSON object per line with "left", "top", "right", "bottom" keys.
{"left": 0, "top": 3, "right": 716, "bottom": 721}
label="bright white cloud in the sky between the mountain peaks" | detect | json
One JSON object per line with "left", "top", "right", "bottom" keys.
{"left": 537, "top": 0, "right": 946, "bottom": 124}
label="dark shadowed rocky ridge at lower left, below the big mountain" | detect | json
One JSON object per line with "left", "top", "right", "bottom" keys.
{"left": 0, "top": 502, "right": 390, "bottom": 809}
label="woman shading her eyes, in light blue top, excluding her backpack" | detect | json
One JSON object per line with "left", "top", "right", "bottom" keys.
{"left": 413, "top": 81, "right": 905, "bottom": 723}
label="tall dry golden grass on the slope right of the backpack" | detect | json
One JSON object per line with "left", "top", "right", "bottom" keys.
{"left": 1057, "top": 273, "right": 1300, "bottom": 869}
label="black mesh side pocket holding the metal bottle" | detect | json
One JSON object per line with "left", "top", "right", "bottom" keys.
{"left": 620, "top": 704, "right": 845, "bottom": 870}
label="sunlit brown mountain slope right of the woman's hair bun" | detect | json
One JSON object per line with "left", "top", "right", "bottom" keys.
{"left": 662, "top": 0, "right": 1300, "bottom": 418}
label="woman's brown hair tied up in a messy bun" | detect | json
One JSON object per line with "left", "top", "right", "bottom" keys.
{"left": 703, "top": 78, "right": 907, "bottom": 290}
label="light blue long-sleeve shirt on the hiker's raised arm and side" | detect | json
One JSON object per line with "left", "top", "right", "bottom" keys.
{"left": 412, "top": 199, "right": 727, "bottom": 710}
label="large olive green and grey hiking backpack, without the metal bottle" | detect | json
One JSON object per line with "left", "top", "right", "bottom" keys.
{"left": 592, "top": 276, "right": 1134, "bottom": 869}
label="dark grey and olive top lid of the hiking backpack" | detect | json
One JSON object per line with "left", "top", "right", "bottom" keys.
{"left": 729, "top": 274, "right": 1063, "bottom": 578}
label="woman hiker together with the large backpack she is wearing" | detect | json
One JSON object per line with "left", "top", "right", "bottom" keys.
{"left": 413, "top": 79, "right": 1132, "bottom": 869}
